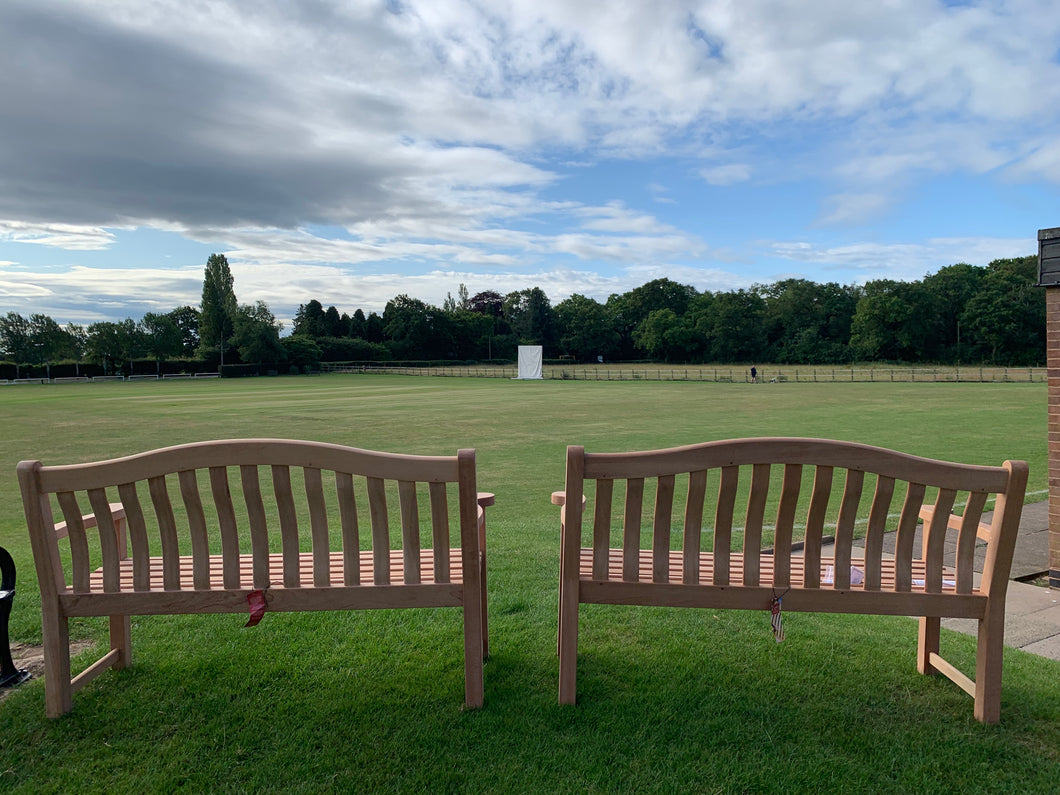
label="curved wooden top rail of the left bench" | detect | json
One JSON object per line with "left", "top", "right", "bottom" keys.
{"left": 19, "top": 439, "right": 473, "bottom": 492}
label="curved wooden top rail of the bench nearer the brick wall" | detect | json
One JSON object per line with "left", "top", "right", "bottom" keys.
{"left": 570, "top": 437, "right": 1026, "bottom": 492}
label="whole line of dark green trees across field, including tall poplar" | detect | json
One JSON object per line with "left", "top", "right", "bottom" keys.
{"left": 0, "top": 254, "right": 1045, "bottom": 372}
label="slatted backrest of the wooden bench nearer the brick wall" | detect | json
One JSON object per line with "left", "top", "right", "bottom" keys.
{"left": 563, "top": 438, "right": 1027, "bottom": 594}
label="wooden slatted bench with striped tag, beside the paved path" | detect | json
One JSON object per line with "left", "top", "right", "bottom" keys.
{"left": 552, "top": 438, "right": 1027, "bottom": 723}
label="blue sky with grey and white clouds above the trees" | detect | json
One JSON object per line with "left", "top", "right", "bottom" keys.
{"left": 0, "top": 0, "right": 1060, "bottom": 325}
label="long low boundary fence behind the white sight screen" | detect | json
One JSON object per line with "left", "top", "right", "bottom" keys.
{"left": 322, "top": 364, "right": 1047, "bottom": 384}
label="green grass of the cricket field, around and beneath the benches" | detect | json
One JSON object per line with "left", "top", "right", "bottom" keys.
{"left": 0, "top": 375, "right": 1060, "bottom": 793}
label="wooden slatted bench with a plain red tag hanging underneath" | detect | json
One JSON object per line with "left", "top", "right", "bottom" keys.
{"left": 18, "top": 439, "right": 493, "bottom": 718}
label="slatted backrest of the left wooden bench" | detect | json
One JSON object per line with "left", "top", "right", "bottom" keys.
{"left": 18, "top": 439, "right": 479, "bottom": 593}
